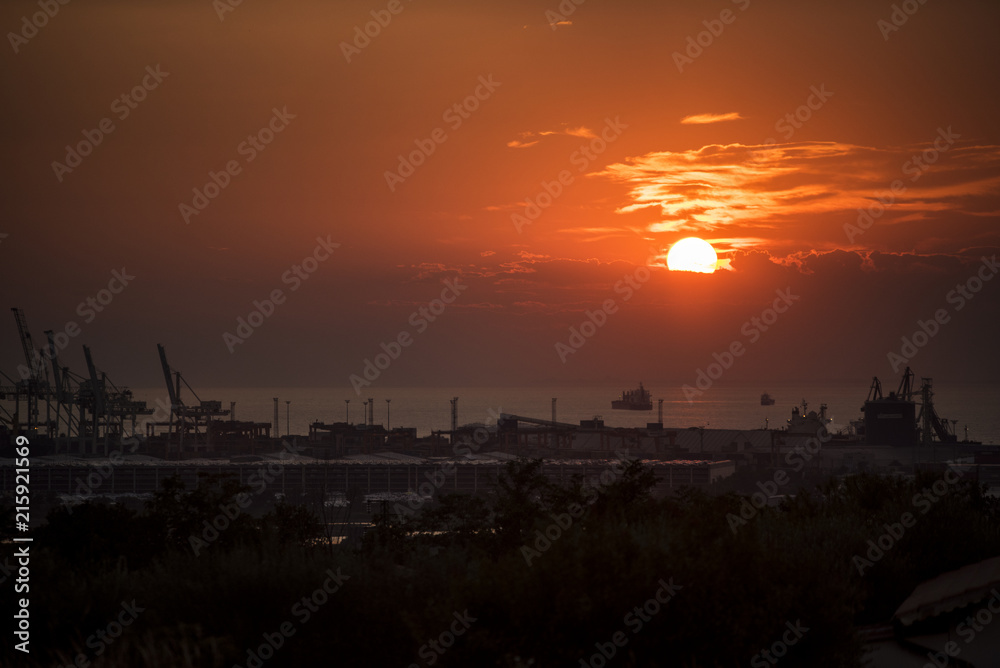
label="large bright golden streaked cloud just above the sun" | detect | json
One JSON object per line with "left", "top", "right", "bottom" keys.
{"left": 598, "top": 142, "right": 1000, "bottom": 250}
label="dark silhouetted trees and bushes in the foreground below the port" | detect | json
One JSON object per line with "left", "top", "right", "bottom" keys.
{"left": 0, "top": 460, "right": 1000, "bottom": 668}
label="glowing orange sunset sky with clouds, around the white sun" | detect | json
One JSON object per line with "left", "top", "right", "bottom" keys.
{"left": 0, "top": 0, "right": 1000, "bottom": 389}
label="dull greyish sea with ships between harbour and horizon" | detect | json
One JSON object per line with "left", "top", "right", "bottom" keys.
{"left": 125, "top": 381, "right": 1000, "bottom": 444}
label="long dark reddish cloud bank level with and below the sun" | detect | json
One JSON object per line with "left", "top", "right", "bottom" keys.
{"left": 394, "top": 248, "right": 1000, "bottom": 331}
